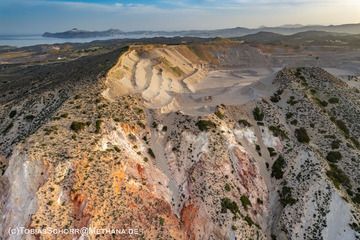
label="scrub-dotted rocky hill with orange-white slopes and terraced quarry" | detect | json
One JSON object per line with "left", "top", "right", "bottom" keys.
{"left": 0, "top": 41, "right": 360, "bottom": 240}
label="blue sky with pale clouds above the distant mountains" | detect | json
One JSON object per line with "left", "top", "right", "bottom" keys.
{"left": 0, "top": 0, "right": 360, "bottom": 34}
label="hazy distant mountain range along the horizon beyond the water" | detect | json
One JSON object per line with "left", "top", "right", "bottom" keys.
{"left": 43, "top": 23, "right": 360, "bottom": 38}
